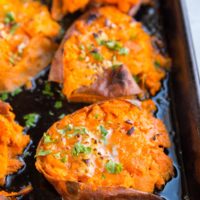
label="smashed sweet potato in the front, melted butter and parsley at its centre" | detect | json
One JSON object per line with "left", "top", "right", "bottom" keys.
{"left": 36, "top": 99, "right": 173, "bottom": 200}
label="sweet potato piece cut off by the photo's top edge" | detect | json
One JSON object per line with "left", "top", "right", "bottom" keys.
{"left": 51, "top": 0, "right": 150, "bottom": 20}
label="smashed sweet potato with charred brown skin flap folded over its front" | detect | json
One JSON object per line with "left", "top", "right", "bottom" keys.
{"left": 49, "top": 7, "right": 170, "bottom": 102}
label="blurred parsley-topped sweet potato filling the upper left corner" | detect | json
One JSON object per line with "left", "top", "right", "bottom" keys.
{"left": 0, "top": 0, "right": 60, "bottom": 92}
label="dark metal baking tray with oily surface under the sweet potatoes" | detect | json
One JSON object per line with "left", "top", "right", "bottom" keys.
{"left": 0, "top": 0, "right": 200, "bottom": 200}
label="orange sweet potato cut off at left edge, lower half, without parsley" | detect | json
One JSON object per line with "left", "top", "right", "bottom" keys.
{"left": 0, "top": 101, "right": 30, "bottom": 186}
